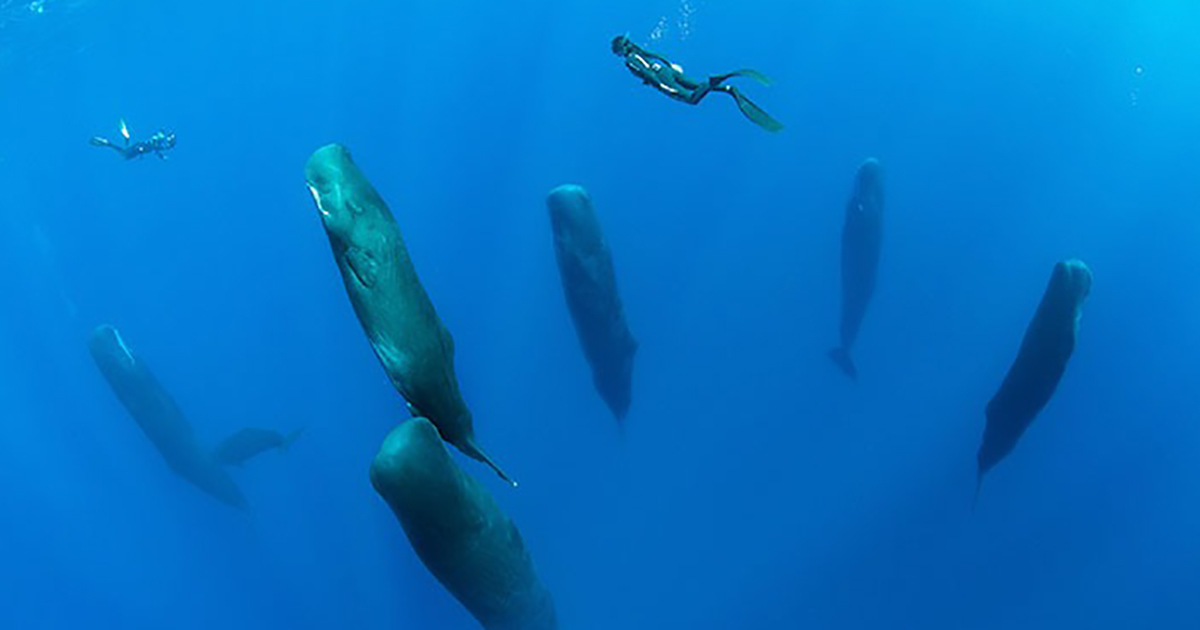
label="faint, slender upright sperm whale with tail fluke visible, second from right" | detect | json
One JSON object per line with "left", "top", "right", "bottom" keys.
{"left": 829, "top": 157, "right": 883, "bottom": 378}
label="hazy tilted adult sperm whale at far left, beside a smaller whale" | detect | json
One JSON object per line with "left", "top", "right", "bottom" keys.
{"left": 88, "top": 325, "right": 248, "bottom": 509}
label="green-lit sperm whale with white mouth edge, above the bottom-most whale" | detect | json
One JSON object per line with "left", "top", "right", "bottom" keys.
{"left": 305, "top": 144, "right": 516, "bottom": 485}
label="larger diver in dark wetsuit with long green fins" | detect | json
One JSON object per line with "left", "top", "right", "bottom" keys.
{"left": 612, "top": 35, "right": 784, "bottom": 131}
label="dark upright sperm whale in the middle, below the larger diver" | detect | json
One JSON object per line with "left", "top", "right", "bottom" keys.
{"left": 546, "top": 185, "right": 637, "bottom": 420}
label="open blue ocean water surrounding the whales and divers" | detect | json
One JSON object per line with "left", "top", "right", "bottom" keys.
{"left": 0, "top": 0, "right": 1200, "bottom": 630}
